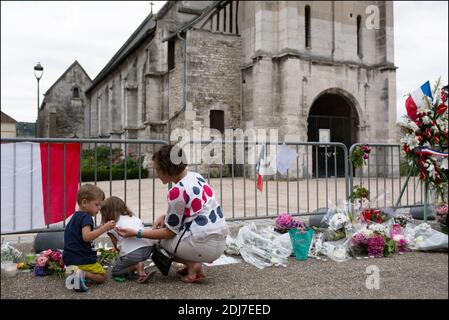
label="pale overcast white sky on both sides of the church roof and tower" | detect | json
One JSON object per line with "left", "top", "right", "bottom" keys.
{"left": 0, "top": 1, "right": 448, "bottom": 122}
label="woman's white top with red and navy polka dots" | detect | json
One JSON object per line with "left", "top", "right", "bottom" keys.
{"left": 165, "top": 171, "right": 229, "bottom": 237}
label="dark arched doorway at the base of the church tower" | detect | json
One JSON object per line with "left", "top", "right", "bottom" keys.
{"left": 307, "top": 92, "right": 359, "bottom": 177}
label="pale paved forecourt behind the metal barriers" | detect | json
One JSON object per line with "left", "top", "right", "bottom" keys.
{"left": 85, "top": 178, "right": 422, "bottom": 223}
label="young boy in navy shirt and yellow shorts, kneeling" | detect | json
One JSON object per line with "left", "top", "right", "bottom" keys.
{"left": 62, "top": 184, "right": 115, "bottom": 292}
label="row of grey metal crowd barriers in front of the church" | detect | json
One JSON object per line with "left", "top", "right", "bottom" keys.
{"left": 1, "top": 138, "right": 423, "bottom": 234}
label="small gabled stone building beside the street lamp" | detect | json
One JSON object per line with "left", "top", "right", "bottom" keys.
{"left": 38, "top": 61, "right": 92, "bottom": 138}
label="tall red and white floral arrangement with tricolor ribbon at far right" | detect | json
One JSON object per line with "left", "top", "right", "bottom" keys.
{"left": 401, "top": 79, "right": 448, "bottom": 198}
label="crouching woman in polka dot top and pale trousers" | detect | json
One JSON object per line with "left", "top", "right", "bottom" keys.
{"left": 117, "top": 145, "right": 229, "bottom": 283}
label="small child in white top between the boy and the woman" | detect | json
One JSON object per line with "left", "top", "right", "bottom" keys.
{"left": 101, "top": 197, "right": 155, "bottom": 283}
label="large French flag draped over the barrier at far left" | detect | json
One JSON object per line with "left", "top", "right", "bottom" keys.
{"left": 1, "top": 142, "right": 80, "bottom": 233}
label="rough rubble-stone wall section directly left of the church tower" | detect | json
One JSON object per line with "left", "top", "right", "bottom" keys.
{"left": 187, "top": 30, "right": 242, "bottom": 129}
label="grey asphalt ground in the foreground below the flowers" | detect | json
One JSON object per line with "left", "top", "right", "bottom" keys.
{"left": 1, "top": 242, "right": 448, "bottom": 299}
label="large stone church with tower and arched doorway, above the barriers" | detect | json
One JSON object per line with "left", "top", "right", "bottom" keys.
{"left": 41, "top": 1, "right": 397, "bottom": 176}
